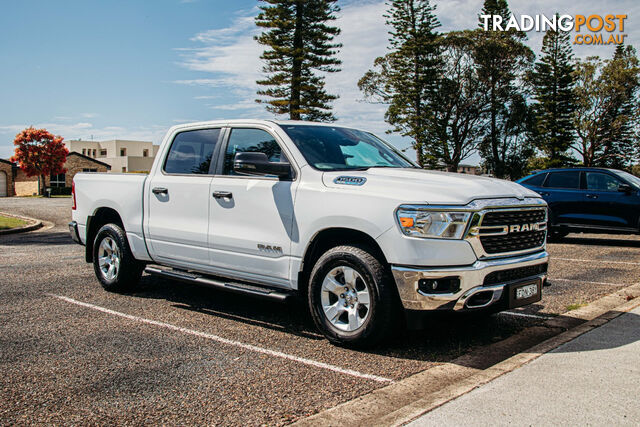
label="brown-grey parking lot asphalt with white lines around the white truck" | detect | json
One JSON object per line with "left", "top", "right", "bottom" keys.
{"left": 0, "top": 198, "right": 640, "bottom": 425}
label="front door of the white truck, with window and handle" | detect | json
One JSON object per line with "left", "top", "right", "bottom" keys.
{"left": 209, "top": 128, "right": 298, "bottom": 286}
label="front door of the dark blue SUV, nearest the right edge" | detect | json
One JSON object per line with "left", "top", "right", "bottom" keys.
{"left": 585, "top": 171, "right": 638, "bottom": 228}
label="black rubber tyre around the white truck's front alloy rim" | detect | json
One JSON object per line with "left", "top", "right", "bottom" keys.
{"left": 308, "top": 245, "right": 400, "bottom": 348}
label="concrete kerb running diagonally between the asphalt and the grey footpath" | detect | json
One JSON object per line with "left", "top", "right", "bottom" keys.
{"left": 295, "top": 284, "right": 640, "bottom": 426}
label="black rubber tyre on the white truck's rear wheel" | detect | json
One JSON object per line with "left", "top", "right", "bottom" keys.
{"left": 93, "top": 224, "right": 144, "bottom": 292}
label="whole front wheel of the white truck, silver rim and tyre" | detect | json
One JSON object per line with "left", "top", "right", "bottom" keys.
{"left": 308, "top": 246, "right": 397, "bottom": 347}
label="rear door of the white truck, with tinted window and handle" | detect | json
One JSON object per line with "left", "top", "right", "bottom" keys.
{"left": 146, "top": 128, "right": 221, "bottom": 267}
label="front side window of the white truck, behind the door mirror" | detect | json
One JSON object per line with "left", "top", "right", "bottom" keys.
{"left": 222, "top": 128, "right": 289, "bottom": 175}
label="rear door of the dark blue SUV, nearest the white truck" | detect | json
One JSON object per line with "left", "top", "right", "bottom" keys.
{"left": 539, "top": 170, "right": 585, "bottom": 225}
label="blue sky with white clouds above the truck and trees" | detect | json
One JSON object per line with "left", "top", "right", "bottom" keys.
{"left": 0, "top": 0, "right": 640, "bottom": 164}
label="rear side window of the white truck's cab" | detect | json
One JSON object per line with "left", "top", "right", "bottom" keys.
{"left": 164, "top": 129, "right": 220, "bottom": 175}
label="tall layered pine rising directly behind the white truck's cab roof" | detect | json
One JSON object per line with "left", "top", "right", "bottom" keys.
{"left": 256, "top": 0, "right": 342, "bottom": 121}
